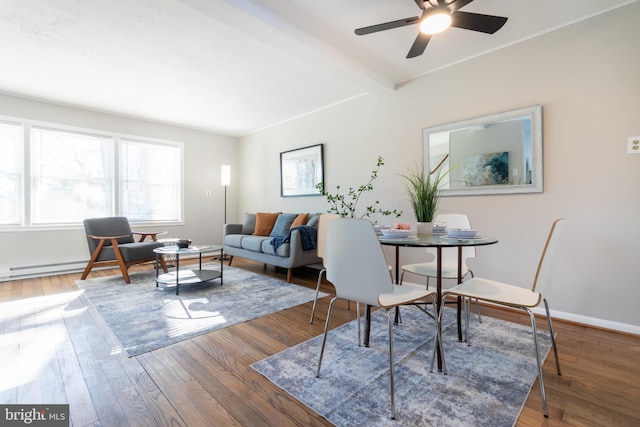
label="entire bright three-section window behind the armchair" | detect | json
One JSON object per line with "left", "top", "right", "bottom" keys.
{"left": 0, "top": 118, "right": 183, "bottom": 229}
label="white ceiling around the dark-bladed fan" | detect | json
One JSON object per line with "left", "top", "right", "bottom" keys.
{"left": 0, "top": 0, "right": 636, "bottom": 136}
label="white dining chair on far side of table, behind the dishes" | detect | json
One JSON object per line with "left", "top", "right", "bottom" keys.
{"left": 400, "top": 213, "right": 482, "bottom": 322}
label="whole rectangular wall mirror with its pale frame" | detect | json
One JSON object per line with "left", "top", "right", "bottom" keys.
{"left": 423, "top": 105, "right": 542, "bottom": 196}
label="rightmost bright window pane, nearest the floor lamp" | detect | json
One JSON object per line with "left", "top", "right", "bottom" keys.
{"left": 120, "top": 139, "right": 181, "bottom": 221}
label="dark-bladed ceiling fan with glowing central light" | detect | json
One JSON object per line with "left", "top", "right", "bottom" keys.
{"left": 355, "top": 0, "right": 507, "bottom": 58}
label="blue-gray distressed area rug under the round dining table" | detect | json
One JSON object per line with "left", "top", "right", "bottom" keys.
{"left": 252, "top": 307, "right": 551, "bottom": 427}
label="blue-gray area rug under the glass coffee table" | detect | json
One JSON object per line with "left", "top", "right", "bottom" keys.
{"left": 76, "top": 263, "right": 327, "bottom": 357}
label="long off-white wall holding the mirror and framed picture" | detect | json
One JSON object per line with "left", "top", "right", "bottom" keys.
{"left": 238, "top": 3, "right": 640, "bottom": 333}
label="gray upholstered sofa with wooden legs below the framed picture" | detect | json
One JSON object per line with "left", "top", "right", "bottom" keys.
{"left": 223, "top": 213, "right": 322, "bottom": 282}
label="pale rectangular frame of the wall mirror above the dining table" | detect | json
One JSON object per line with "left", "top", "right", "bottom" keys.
{"left": 422, "top": 105, "right": 543, "bottom": 196}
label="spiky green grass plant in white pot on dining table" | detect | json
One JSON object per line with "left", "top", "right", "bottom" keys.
{"left": 401, "top": 155, "right": 451, "bottom": 234}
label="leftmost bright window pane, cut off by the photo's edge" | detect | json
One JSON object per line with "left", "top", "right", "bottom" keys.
{"left": 0, "top": 122, "right": 24, "bottom": 225}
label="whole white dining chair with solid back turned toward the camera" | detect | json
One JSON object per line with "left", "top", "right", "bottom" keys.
{"left": 316, "top": 218, "right": 446, "bottom": 419}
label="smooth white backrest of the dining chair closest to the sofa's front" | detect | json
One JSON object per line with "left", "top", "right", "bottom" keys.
{"left": 325, "top": 218, "right": 393, "bottom": 306}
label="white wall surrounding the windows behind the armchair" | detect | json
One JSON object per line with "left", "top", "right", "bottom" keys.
{"left": 0, "top": 94, "right": 238, "bottom": 280}
